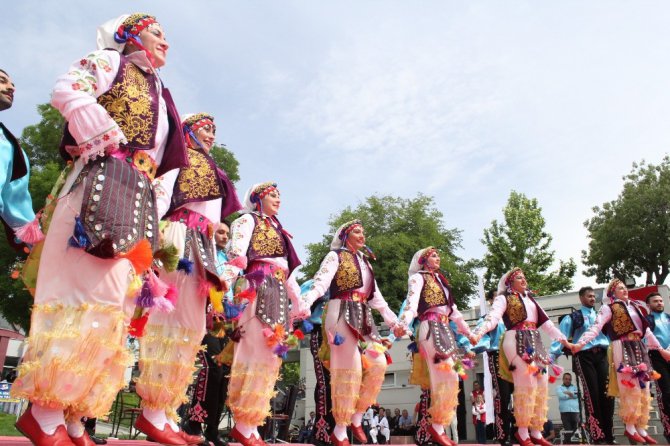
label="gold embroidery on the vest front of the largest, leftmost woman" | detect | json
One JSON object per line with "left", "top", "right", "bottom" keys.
{"left": 98, "top": 63, "right": 154, "bottom": 146}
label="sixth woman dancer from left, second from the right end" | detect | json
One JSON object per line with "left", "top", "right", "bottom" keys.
{"left": 472, "top": 268, "right": 572, "bottom": 446}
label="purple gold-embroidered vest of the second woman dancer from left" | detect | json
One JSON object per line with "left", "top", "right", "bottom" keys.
{"left": 167, "top": 149, "right": 242, "bottom": 220}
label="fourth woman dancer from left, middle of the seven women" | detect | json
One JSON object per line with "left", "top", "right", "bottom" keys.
{"left": 303, "top": 220, "right": 404, "bottom": 446}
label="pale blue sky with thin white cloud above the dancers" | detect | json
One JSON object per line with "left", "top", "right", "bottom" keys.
{"left": 0, "top": 0, "right": 670, "bottom": 288}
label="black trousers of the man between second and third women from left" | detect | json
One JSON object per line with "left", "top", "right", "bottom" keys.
{"left": 186, "top": 333, "right": 230, "bottom": 439}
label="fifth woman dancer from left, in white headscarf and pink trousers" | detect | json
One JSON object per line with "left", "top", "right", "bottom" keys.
{"left": 398, "top": 246, "right": 472, "bottom": 446}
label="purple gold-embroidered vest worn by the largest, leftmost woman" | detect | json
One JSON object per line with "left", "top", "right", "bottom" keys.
{"left": 60, "top": 54, "right": 188, "bottom": 176}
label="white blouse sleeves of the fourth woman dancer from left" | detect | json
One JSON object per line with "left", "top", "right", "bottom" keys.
{"left": 303, "top": 247, "right": 398, "bottom": 327}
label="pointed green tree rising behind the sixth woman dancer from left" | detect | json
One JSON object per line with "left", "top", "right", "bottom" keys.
{"left": 481, "top": 191, "right": 577, "bottom": 296}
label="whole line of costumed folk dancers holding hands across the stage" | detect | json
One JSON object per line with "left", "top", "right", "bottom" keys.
{"left": 0, "top": 9, "right": 670, "bottom": 446}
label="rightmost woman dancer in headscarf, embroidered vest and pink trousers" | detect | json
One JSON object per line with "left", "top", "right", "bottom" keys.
{"left": 573, "top": 279, "right": 670, "bottom": 444}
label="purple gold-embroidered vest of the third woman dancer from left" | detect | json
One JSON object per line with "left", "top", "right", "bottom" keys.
{"left": 247, "top": 213, "right": 300, "bottom": 275}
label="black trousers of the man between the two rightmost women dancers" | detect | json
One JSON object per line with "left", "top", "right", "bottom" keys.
{"left": 572, "top": 347, "right": 614, "bottom": 442}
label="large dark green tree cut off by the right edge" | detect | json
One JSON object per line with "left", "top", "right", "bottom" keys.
{"left": 582, "top": 155, "right": 670, "bottom": 285}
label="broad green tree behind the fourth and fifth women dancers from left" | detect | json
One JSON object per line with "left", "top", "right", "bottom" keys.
{"left": 302, "top": 194, "right": 476, "bottom": 311}
